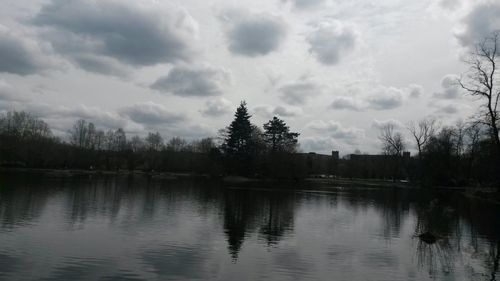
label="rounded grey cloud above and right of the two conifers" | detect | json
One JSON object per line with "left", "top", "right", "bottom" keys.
{"left": 306, "top": 21, "right": 357, "bottom": 65}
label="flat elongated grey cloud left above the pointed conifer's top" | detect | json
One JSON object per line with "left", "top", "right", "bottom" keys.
{"left": 118, "top": 102, "right": 187, "bottom": 126}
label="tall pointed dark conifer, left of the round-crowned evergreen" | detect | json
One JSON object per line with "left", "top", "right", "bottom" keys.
{"left": 222, "top": 101, "right": 253, "bottom": 155}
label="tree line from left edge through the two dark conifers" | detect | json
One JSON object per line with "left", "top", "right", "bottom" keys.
{"left": 0, "top": 102, "right": 299, "bottom": 176}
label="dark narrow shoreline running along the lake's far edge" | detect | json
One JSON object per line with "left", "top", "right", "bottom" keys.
{"left": 0, "top": 167, "right": 500, "bottom": 204}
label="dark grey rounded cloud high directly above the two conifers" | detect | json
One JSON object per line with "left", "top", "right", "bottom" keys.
{"left": 221, "top": 11, "right": 287, "bottom": 57}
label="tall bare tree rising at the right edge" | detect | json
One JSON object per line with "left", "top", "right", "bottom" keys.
{"left": 458, "top": 31, "right": 500, "bottom": 153}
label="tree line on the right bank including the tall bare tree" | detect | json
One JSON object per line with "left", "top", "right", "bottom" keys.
{"left": 379, "top": 31, "right": 500, "bottom": 189}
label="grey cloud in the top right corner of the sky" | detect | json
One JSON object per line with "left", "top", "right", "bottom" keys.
{"left": 456, "top": 1, "right": 500, "bottom": 48}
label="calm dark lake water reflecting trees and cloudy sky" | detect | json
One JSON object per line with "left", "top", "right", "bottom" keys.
{"left": 0, "top": 176, "right": 500, "bottom": 281}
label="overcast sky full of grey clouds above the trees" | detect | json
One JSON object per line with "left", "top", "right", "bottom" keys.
{"left": 0, "top": 0, "right": 500, "bottom": 154}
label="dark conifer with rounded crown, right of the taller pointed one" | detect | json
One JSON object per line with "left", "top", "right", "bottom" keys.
{"left": 264, "top": 116, "right": 299, "bottom": 152}
